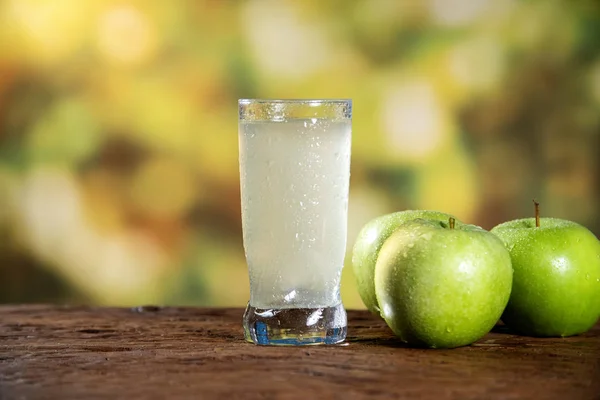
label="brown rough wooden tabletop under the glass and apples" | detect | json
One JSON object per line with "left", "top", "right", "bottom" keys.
{"left": 0, "top": 305, "right": 600, "bottom": 400}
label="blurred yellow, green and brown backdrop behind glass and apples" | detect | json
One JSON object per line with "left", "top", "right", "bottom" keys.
{"left": 0, "top": 0, "right": 600, "bottom": 308}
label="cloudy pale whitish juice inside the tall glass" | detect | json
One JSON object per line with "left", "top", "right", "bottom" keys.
{"left": 239, "top": 118, "right": 351, "bottom": 309}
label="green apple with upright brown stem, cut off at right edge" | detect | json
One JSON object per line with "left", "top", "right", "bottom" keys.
{"left": 492, "top": 217, "right": 600, "bottom": 336}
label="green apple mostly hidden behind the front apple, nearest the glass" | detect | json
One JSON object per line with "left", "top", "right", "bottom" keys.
{"left": 352, "top": 210, "right": 454, "bottom": 315}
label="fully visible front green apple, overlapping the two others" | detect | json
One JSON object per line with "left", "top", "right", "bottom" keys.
{"left": 375, "top": 220, "right": 513, "bottom": 348}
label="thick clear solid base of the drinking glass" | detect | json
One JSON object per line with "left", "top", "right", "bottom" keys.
{"left": 244, "top": 303, "right": 347, "bottom": 346}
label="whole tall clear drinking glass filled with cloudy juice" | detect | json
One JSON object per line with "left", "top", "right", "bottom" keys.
{"left": 238, "top": 100, "right": 352, "bottom": 345}
